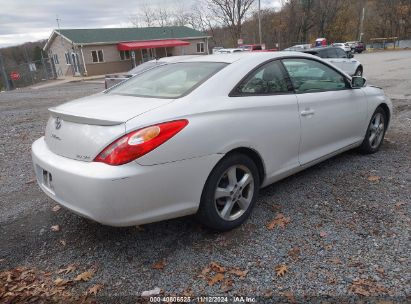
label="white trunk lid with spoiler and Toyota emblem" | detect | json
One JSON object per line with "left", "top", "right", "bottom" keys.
{"left": 45, "top": 94, "right": 172, "bottom": 161}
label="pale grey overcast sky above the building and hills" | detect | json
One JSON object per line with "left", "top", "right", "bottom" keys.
{"left": 0, "top": 0, "right": 280, "bottom": 48}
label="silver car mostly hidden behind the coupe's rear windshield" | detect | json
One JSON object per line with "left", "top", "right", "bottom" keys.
{"left": 104, "top": 55, "right": 201, "bottom": 89}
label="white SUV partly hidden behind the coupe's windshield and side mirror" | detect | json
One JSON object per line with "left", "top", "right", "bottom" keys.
{"left": 303, "top": 46, "right": 364, "bottom": 76}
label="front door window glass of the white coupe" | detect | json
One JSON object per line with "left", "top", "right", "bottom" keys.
{"left": 283, "top": 59, "right": 347, "bottom": 93}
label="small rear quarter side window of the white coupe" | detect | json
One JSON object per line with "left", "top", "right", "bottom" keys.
{"left": 236, "top": 61, "right": 289, "bottom": 95}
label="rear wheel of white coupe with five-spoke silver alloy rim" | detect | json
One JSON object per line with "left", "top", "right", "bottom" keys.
{"left": 197, "top": 153, "right": 260, "bottom": 231}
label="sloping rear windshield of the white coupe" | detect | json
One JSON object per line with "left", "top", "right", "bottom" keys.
{"left": 108, "top": 62, "right": 227, "bottom": 98}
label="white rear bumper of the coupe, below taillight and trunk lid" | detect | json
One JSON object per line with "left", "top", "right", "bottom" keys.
{"left": 32, "top": 137, "right": 222, "bottom": 226}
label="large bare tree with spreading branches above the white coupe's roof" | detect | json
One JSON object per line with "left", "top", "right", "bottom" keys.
{"left": 208, "top": 0, "right": 254, "bottom": 43}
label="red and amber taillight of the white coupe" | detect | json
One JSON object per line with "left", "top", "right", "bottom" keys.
{"left": 94, "top": 119, "right": 188, "bottom": 166}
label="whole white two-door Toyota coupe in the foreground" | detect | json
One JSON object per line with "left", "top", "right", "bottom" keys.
{"left": 32, "top": 52, "right": 392, "bottom": 230}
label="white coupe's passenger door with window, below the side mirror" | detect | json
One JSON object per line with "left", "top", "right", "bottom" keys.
{"left": 282, "top": 58, "right": 367, "bottom": 165}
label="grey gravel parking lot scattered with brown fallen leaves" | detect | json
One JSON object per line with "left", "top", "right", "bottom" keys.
{"left": 0, "top": 51, "right": 411, "bottom": 303}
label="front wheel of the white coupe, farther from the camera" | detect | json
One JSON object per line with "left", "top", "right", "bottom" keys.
{"left": 360, "top": 107, "right": 387, "bottom": 154}
